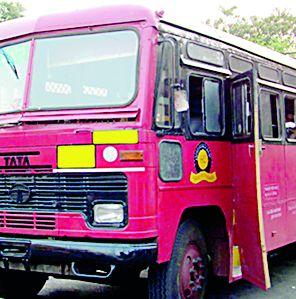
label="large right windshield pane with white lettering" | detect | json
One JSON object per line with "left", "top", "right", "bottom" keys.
{"left": 28, "top": 30, "right": 139, "bottom": 110}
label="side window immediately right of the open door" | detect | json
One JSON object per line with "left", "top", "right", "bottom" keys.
{"left": 260, "top": 90, "right": 280, "bottom": 140}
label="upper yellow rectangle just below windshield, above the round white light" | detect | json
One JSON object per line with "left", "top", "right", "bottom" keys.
{"left": 93, "top": 130, "right": 139, "bottom": 144}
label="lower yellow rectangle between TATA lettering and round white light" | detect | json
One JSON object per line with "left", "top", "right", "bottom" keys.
{"left": 57, "top": 144, "right": 96, "bottom": 168}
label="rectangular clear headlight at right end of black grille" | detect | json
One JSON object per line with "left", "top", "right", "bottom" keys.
{"left": 93, "top": 203, "right": 124, "bottom": 223}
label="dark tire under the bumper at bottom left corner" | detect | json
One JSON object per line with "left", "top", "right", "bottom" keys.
{"left": 0, "top": 271, "right": 47, "bottom": 299}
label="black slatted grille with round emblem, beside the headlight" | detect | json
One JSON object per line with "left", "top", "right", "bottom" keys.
{"left": 0, "top": 173, "right": 127, "bottom": 214}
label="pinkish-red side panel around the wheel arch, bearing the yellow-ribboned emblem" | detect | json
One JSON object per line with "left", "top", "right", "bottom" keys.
{"left": 158, "top": 136, "right": 233, "bottom": 262}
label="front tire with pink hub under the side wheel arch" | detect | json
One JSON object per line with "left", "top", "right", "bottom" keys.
{"left": 148, "top": 220, "right": 208, "bottom": 299}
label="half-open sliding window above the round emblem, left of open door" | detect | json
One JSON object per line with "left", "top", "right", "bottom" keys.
{"left": 189, "top": 75, "right": 223, "bottom": 134}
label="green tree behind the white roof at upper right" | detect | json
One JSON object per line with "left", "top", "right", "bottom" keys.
{"left": 207, "top": 6, "right": 296, "bottom": 56}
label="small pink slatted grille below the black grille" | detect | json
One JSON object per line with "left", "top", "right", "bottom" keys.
{"left": 0, "top": 211, "right": 56, "bottom": 230}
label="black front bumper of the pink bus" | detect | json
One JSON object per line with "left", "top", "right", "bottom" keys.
{"left": 0, "top": 237, "right": 157, "bottom": 280}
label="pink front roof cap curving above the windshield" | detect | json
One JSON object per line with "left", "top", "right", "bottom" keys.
{"left": 0, "top": 5, "right": 157, "bottom": 42}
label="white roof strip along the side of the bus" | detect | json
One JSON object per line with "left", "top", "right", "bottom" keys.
{"left": 161, "top": 20, "right": 296, "bottom": 69}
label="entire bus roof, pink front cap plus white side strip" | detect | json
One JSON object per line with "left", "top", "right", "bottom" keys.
{"left": 0, "top": 5, "right": 296, "bottom": 69}
